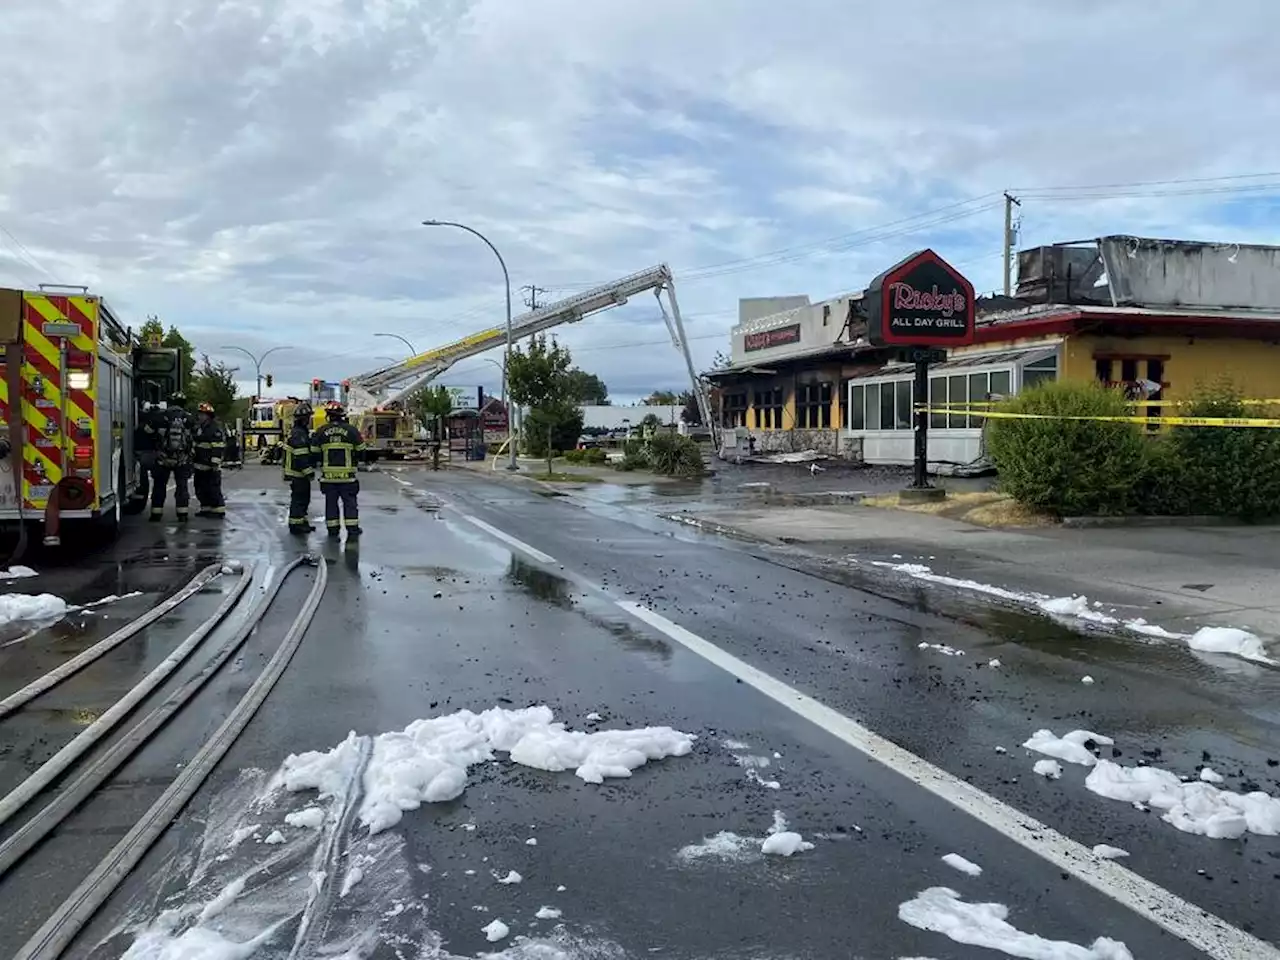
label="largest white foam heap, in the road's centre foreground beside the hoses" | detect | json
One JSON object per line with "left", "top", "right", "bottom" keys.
{"left": 283, "top": 707, "right": 696, "bottom": 833}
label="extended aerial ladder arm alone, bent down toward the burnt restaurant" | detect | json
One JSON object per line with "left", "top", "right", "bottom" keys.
{"left": 348, "top": 264, "right": 714, "bottom": 448}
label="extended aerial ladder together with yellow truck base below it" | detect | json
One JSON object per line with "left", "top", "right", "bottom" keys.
{"left": 325, "top": 264, "right": 719, "bottom": 458}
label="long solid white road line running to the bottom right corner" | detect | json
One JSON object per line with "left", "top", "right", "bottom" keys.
{"left": 614, "top": 601, "right": 1280, "bottom": 960}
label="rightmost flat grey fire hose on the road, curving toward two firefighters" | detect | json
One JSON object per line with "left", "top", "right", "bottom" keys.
{"left": 14, "top": 557, "right": 329, "bottom": 960}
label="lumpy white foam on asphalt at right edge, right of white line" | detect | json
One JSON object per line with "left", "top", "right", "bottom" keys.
{"left": 1084, "top": 760, "right": 1280, "bottom": 840}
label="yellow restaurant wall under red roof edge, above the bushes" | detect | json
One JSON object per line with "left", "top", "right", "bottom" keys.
{"left": 1060, "top": 335, "right": 1280, "bottom": 399}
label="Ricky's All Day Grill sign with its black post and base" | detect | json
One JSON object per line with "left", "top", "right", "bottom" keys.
{"left": 864, "top": 250, "right": 974, "bottom": 499}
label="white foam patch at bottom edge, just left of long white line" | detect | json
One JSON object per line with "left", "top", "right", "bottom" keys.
{"left": 897, "top": 887, "right": 1133, "bottom": 960}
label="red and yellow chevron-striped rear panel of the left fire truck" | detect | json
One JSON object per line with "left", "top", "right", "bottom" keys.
{"left": 0, "top": 292, "right": 99, "bottom": 509}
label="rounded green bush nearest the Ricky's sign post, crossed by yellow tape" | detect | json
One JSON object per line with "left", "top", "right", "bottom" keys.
{"left": 987, "top": 381, "right": 1147, "bottom": 517}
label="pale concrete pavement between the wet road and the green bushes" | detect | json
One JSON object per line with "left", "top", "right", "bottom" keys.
{"left": 664, "top": 506, "right": 1280, "bottom": 649}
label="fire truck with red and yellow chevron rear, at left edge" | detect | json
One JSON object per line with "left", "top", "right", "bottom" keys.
{"left": 0, "top": 284, "right": 182, "bottom": 545}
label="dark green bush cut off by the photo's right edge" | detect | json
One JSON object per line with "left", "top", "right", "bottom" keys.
{"left": 1169, "top": 380, "right": 1280, "bottom": 521}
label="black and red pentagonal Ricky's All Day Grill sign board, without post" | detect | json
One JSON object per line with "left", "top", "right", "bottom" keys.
{"left": 864, "top": 250, "right": 974, "bottom": 347}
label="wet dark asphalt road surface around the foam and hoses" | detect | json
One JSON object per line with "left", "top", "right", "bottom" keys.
{"left": 0, "top": 468, "right": 1280, "bottom": 960}
